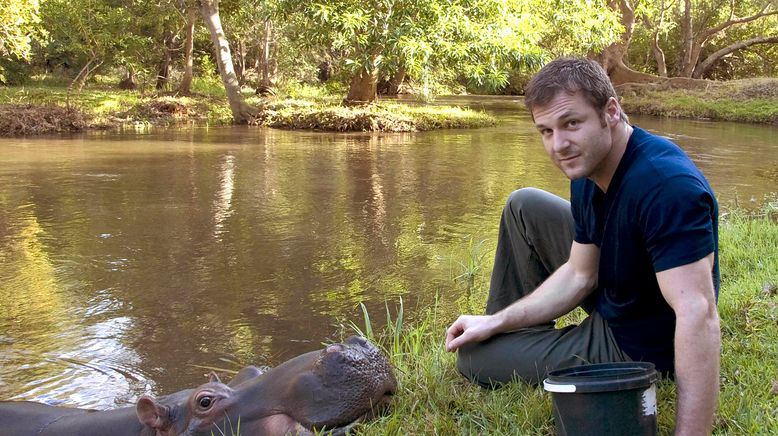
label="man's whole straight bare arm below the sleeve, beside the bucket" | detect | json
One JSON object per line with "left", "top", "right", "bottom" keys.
{"left": 656, "top": 253, "right": 721, "bottom": 435}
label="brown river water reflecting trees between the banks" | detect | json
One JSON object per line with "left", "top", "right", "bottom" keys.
{"left": 0, "top": 97, "right": 778, "bottom": 408}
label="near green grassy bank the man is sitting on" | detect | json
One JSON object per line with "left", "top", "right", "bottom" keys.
{"left": 359, "top": 203, "right": 778, "bottom": 435}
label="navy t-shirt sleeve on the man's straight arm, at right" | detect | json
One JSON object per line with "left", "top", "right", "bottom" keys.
{"left": 641, "top": 175, "right": 716, "bottom": 272}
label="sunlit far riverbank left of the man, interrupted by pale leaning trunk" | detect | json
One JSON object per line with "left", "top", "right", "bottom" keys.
{"left": 0, "top": 81, "right": 497, "bottom": 136}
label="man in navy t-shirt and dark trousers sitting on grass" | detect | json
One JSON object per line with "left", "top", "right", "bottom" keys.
{"left": 446, "top": 58, "right": 720, "bottom": 434}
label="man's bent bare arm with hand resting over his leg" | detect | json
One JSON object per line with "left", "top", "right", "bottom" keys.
{"left": 446, "top": 242, "right": 600, "bottom": 351}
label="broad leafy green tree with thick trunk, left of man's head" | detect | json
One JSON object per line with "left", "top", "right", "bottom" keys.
{"left": 282, "top": 0, "right": 618, "bottom": 103}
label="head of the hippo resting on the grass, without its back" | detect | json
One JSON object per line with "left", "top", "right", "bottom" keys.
{"left": 136, "top": 336, "right": 397, "bottom": 436}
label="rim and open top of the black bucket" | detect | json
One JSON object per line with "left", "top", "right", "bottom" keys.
{"left": 543, "top": 362, "right": 658, "bottom": 393}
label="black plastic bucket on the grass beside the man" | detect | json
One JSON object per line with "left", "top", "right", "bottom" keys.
{"left": 543, "top": 362, "right": 657, "bottom": 436}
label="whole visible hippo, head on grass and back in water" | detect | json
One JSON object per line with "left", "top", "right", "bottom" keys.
{"left": 0, "top": 336, "right": 397, "bottom": 436}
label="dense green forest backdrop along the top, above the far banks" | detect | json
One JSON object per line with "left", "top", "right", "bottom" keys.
{"left": 0, "top": 0, "right": 778, "bottom": 102}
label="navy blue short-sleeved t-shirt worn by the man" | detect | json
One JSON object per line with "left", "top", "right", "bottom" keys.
{"left": 570, "top": 127, "right": 719, "bottom": 372}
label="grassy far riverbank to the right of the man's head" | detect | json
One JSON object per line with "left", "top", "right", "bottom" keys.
{"left": 618, "top": 78, "right": 778, "bottom": 125}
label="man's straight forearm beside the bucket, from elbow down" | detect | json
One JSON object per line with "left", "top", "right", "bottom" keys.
{"left": 675, "top": 306, "right": 721, "bottom": 435}
